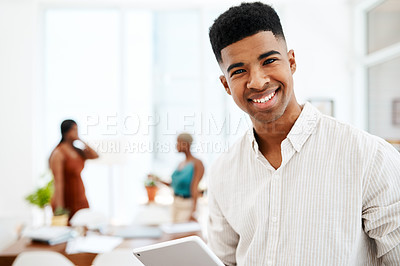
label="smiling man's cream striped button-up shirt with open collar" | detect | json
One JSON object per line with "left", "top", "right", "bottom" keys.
{"left": 208, "top": 103, "right": 400, "bottom": 266}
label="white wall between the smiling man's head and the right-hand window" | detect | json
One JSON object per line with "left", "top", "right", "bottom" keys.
{"left": 281, "top": 1, "right": 353, "bottom": 123}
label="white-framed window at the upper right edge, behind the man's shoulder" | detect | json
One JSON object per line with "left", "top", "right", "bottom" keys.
{"left": 364, "top": 0, "right": 400, "bottom": 141}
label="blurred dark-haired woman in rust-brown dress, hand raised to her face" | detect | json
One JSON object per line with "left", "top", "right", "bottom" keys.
{"left": 49, "top": 119, "right": 99, "bottom": 218}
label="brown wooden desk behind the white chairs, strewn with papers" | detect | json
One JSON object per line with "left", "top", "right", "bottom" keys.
{"left": 0, "top": 232, "right": 201, "bottom": 266}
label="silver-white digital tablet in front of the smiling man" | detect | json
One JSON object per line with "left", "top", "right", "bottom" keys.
{"left": 133, "top": 236, "right": 224, "bottom": 266}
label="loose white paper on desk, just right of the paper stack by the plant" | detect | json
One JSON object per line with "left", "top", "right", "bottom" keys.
{"left": 65, "top": 235, "right": 122, "bottom": 254}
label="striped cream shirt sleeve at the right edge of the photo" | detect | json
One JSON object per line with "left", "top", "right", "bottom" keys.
{"left": 362, "top": 140, "right": 400, "bottom": 265}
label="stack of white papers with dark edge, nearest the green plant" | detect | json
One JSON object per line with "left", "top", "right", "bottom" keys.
{"left": 23, "top": 226, "right": 76, "bottom": 245}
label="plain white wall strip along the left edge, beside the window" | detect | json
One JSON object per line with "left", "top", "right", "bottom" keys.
{"left": 0, "top": 1, "right": 35, "bottom": 216}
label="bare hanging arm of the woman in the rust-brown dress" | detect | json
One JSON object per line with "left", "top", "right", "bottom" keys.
{"left": 50, "top": 149, "right": 64, "bottom": 210}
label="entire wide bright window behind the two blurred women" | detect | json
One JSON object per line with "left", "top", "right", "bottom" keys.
{"left": 40, "top": 8, "right": 236, "bottom": 223}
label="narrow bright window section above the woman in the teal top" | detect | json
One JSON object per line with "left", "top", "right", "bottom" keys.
{"left": 154, "top": 10, "right": 204, "bottom": 164}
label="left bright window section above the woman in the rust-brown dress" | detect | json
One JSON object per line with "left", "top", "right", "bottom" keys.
{"left": 44, "top": 9, "right": 121, "bottom": 141}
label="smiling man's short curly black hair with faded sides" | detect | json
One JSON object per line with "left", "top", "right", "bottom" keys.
{"left": 209, "top": 2, "right": 285, "bottom": 63}
